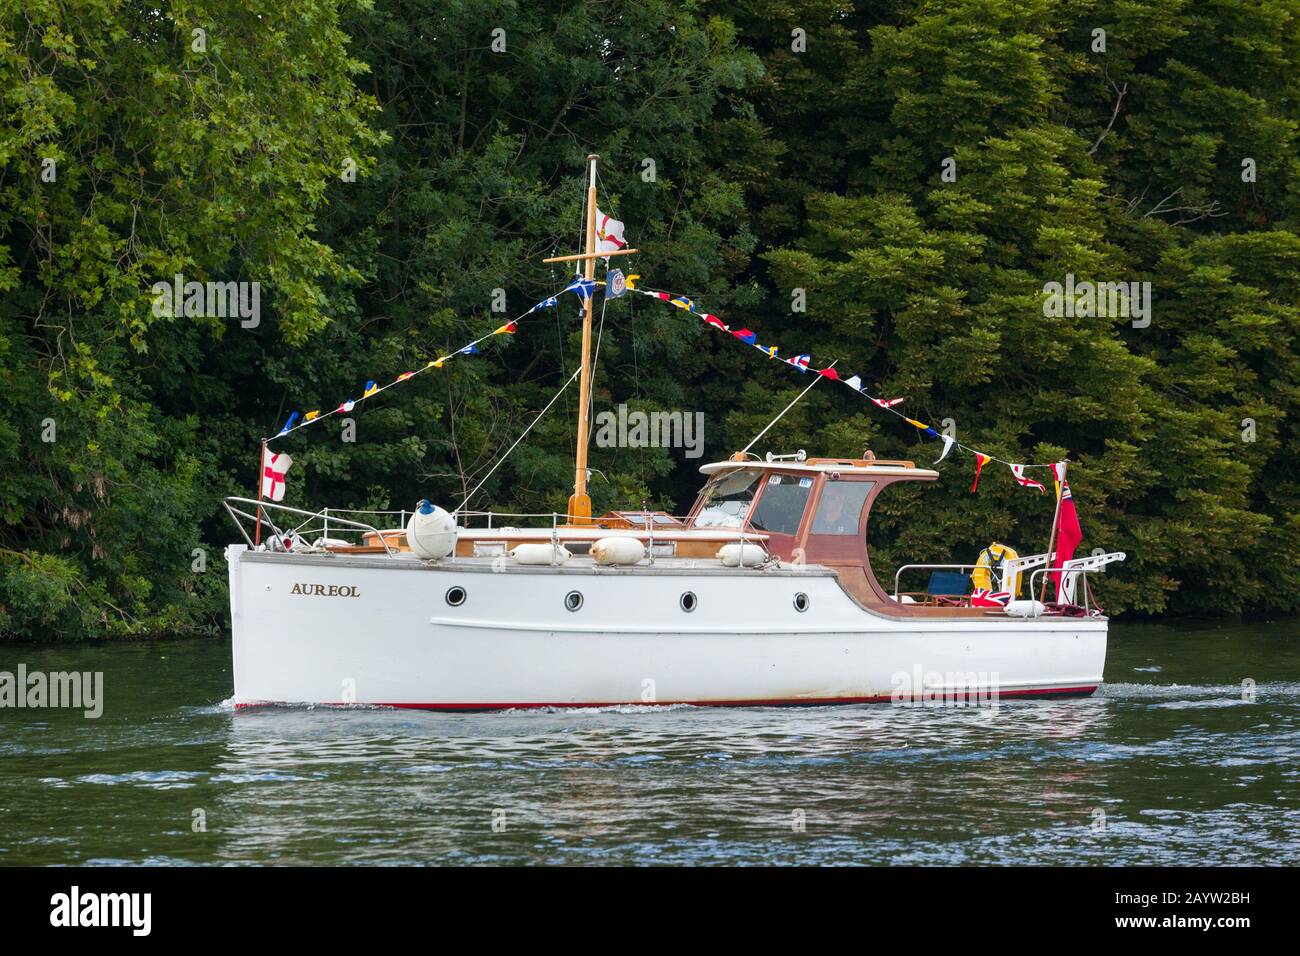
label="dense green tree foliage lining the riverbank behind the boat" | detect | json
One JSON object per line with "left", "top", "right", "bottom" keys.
{"left": 0, "top": 0, "right": 1300, "bottom": 637}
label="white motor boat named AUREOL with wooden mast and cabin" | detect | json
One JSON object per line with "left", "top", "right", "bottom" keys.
{"left": 225, "top": 156, "right": 1125, "bottom": 710}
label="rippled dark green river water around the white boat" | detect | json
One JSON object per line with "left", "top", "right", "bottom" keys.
{"left": 0, "top": 620, "right": 1300, "bottom": 865}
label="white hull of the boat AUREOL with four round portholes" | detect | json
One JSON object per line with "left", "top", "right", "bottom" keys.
{"left": 226, "top": 546, "right": 1106, "bottom": 710}
